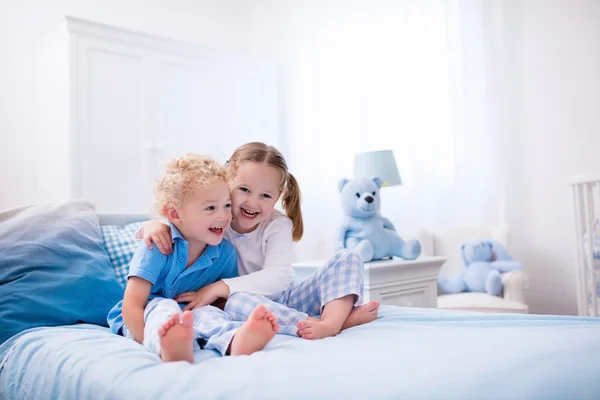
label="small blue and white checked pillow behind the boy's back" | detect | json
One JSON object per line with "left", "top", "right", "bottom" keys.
{"left": 101, "top": 222, "right": 143, "bottom": 287}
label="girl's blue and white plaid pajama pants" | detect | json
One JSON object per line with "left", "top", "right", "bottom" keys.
{"left": 225, "top": 250, "right": 364, "bottom": 336}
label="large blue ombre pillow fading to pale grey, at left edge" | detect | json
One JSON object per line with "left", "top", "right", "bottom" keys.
{"left": 0, "top": 199, "right": 123, "bottom": 344}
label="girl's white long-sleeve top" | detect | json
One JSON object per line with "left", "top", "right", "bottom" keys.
{"left": 223, "top": 210, "right": 294, "bottom": 296}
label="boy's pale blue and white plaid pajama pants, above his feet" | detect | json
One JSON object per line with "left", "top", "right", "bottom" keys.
{"left": 122, "top": 297, "right": 244, "bottom": 355}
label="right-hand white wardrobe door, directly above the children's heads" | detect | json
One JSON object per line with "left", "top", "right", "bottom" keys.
{"left": 153, "top": 54, "right": 280, "bottom": 170}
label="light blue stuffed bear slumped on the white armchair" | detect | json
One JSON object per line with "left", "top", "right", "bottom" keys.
{"left": 438, "top": 240, "right": 523, "bottom": 296}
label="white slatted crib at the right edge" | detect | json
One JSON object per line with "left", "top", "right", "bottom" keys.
{"left": 571, "top": 173, "right": 600, "bottom": 317}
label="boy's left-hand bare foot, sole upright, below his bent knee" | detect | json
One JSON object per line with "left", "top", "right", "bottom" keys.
{"left": 158, "top": 311, "right": 194, "bottom": 363}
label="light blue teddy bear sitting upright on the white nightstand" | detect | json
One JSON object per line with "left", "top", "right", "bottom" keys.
{"left": 335, "top": 178, "right": 421, "bottom": 262}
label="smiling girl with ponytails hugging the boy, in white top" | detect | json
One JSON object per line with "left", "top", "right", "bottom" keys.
{"left": 136, "top": 142, "right": 379, "bottom": 339}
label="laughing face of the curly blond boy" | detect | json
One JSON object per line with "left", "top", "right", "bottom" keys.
{"left": 169, "top": 179, "right": 231, "bottom": 246}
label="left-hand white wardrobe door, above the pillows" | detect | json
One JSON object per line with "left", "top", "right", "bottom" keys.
{"left": 72, "top": 36, "right": 152, "bottom": 213}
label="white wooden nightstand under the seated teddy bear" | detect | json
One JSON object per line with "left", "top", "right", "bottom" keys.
{"left": 292, "top": 257, "right": 446, "bottom": 308}
